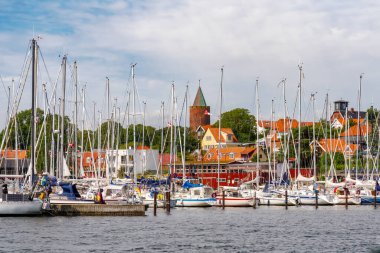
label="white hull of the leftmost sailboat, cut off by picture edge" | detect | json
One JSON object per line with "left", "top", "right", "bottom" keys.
{"left": 0, "top": 199, "right": 43, "bottom": 216}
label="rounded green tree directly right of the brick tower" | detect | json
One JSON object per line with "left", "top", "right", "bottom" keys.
{"left": 213, "top": 108, "right": 256, "bottom": 142}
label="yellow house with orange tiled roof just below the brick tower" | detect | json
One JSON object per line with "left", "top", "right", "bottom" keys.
{"left": 201, "top": 128, "right": 238, "bottom": 150}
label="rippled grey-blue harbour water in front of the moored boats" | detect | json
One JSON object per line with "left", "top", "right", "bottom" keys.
{"left": 0, "top": 206, "right": 380, "bottom": 252}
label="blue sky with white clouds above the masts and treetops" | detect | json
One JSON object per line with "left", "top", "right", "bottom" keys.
{"left": 0, "top": 0, "right": 380, "bottom": 127}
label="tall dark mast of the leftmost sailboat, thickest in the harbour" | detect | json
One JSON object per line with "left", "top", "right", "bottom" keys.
{"left": 30, "top": 39, "right": 38, "bottom": 187}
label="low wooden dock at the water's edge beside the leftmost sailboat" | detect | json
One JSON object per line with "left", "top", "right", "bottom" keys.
{"left": 49, "top": 204, "right": 148, "bottom": 216}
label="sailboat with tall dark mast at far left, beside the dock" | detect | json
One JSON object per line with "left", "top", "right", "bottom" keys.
{"left": 0, "top": 39, "right": 43, "bottom": 216}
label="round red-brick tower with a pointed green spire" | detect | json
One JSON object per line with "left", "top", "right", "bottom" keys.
{"left": 190, "top": 86, "right": 210, "bottom": 131}
